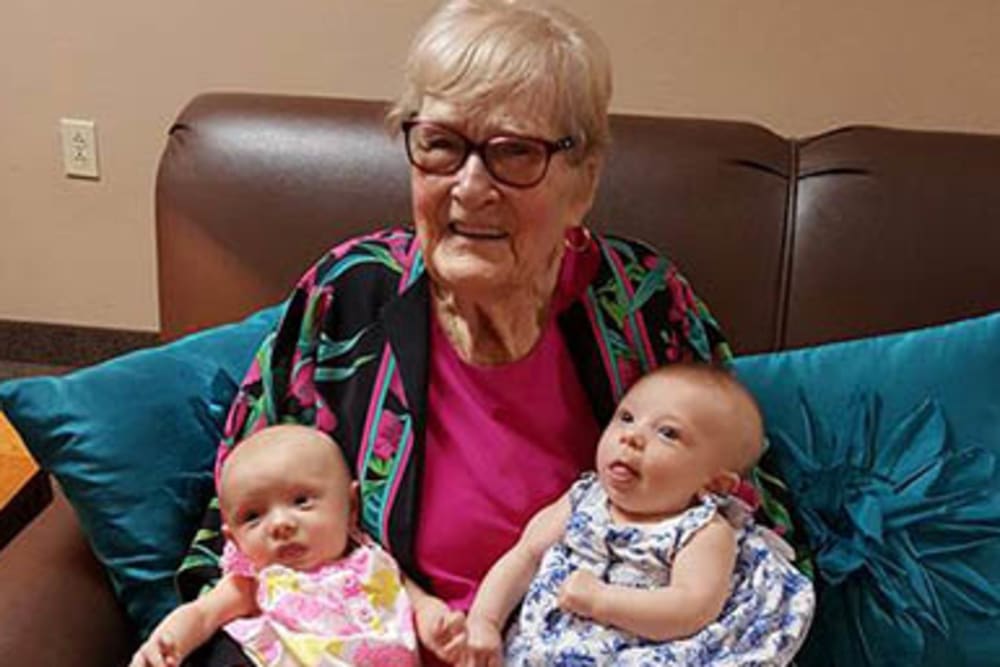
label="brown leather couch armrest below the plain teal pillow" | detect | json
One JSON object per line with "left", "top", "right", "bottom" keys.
{"left": 0, "top": 482, "right": 131, "bottom": 667}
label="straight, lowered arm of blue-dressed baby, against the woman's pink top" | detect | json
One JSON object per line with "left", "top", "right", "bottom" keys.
{"left": 463, "top": 495, "right": 572, "bottom": 667}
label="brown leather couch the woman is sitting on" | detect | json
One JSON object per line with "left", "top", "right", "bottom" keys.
{"left": 0, "top": 94, "right": 1000, "bottom": 667}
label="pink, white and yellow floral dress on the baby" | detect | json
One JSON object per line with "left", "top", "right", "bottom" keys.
{"left": 221, "top": 542, "right": 419, "bottom": 667}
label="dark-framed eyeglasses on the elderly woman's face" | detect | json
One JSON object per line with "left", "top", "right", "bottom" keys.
{"left": 403, "top": 119, "right": 576, "bottom": 188}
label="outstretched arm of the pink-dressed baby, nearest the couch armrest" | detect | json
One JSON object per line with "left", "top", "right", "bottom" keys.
{"left": 129, "top": 575, "right": 259, "bottom": 667}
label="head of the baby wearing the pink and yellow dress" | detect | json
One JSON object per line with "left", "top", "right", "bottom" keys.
{"left": 219, "top": 425, "right": 357, "bottom": 570}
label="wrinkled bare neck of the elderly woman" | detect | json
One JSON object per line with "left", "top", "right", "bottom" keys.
{"left": 431, "top": 263, "right": 558, "bottom": 366}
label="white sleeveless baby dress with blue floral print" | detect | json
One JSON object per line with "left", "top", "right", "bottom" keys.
{"left": 505, "top": 473, "right": 815, "bottom": 667}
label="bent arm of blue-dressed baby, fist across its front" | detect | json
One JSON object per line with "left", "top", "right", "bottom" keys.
{"left": 559, "top": 516, "right": 736, "bottom": 641}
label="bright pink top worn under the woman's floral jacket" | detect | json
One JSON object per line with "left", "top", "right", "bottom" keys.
{"left": 415, "top": 247, "right": 600, "bottom": 664}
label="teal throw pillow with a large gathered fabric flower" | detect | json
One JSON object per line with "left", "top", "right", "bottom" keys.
{"left": 735, "top": 311, "right": 1000, "bottom": 667}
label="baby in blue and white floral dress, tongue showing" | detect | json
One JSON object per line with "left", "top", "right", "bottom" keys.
{"left": 463, "top": 365, "right": 815, "bottom": 666}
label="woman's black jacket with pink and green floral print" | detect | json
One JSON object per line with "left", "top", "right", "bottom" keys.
{"left": 178, "top": 227, "right": 730, "bottom": 599}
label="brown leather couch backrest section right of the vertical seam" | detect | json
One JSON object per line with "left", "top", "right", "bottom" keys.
{"left": 784, "top": 127, "right": 1000, "bottom": 347}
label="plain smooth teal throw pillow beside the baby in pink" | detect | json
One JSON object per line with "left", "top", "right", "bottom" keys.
{"left": 0, "top": 306, "right": 280, "bottom": 636}
